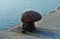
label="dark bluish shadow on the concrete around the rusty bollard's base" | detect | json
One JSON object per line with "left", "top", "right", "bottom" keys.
{"left": 10, "top": 27, "right": 55, "bottom": 37}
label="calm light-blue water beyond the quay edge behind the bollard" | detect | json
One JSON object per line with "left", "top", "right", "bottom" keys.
{"left": 0, "top": 0, "right": 60, "bottom": 29}
